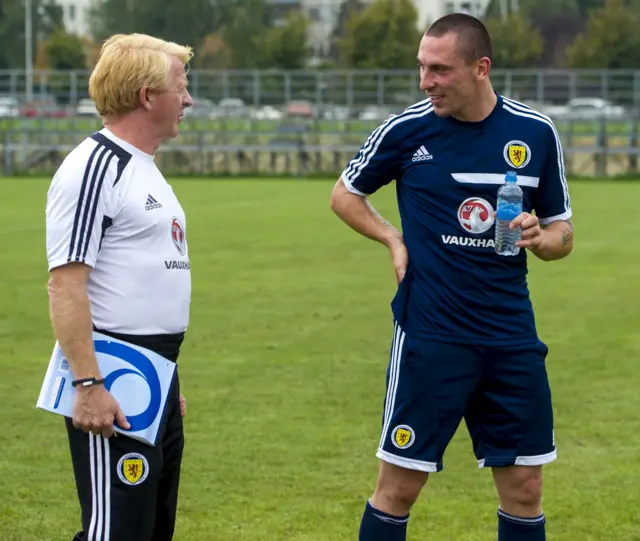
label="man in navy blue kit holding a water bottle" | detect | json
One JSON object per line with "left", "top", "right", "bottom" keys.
{"left": 331, "top": 14, "right": 573, "bottom": 541}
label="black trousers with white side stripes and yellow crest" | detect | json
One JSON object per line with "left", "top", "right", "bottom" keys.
{"left": 65, "top": 331, "right": 184, "bottom": 541}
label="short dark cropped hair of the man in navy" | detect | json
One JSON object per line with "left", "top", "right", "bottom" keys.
{"left": 425, "top": 13, "right": 493, "bottom": 63}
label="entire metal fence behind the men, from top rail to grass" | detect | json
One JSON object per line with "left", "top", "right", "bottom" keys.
{"left": 0, "top": 70, "right": 640, "bottom": 177}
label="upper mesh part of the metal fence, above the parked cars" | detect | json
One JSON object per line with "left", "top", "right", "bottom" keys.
{"left": 0, "top": 69, "right": 640, "bottom": 109}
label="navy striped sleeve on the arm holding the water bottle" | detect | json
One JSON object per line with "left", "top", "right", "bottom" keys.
{"left": 535, "top": 122, "right": 572, "bottom": 225}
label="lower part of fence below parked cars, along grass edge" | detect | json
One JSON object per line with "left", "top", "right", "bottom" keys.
{"left": 0, "top": 116, "right": 640, "bottom": 178}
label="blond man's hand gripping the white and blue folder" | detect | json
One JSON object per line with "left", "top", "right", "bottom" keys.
{"left": 73, "top": 385, "right": 131, "bottom": 438}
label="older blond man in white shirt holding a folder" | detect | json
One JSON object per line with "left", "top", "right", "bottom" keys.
{"left": 46, "top": 34, "right": 193, "bottom": 541}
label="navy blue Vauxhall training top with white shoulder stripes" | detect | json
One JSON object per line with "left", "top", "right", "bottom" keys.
{"left": 342, "top": 96, "right": 571, "bottom": 345}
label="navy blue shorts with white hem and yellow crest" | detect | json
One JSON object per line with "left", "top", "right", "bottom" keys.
{"left": 376, "top": 323, "right": 556, "bottom": 472}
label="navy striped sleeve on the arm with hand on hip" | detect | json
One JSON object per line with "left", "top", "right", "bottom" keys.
{"left": 342, "top": 115, "right": 400, "bottom": 197}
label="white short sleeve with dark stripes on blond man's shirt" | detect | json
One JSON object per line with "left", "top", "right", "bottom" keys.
{"left": 46, "top": 153, "right": 119, "bottom": 271}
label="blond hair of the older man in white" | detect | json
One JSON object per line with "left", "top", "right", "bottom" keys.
{"left": 89, "top": 34, "right": 193, "bottom": 116}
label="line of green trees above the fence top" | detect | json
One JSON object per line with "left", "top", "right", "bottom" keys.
{"left": 0, "top": 0, "right": 640, "bottom": 70}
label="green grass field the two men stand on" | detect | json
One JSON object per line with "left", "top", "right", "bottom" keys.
{"left": 0, "top": 179, "right": 640, "bottom": 541}
